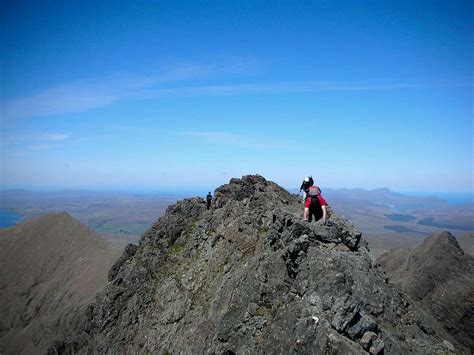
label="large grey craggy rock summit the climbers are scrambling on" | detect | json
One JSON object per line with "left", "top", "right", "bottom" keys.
{"left": 49, "top": 175, "right": 462, "bottom": 354}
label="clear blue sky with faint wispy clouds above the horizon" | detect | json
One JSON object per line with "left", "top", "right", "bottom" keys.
{"left": 0, "top": 0, "right": 474, "bottom": 193}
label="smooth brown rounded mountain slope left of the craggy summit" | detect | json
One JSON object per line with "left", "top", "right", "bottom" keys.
{"left": 0, "top": 213, "right": 120, "bottom": 354}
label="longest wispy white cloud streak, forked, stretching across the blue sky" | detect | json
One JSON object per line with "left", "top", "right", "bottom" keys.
{"left": 3, "top": 72, "right": 473, "bottom": 119}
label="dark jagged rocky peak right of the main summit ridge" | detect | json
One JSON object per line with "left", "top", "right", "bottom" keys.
{"left": 377, "top": 232, "right": 474, "bottom": 352}
